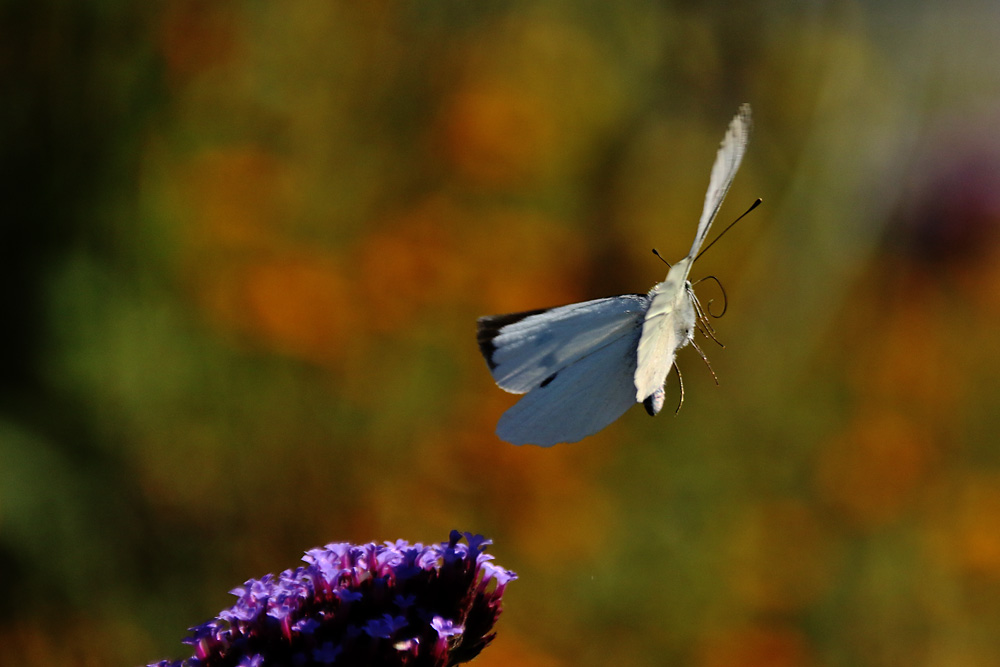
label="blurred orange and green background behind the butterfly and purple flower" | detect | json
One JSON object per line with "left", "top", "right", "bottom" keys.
{"left": 0, "top": 0, "right": 1000, "bottom": 667}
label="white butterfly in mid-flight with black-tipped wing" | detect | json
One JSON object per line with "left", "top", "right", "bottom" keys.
{"left": 477, "top": 104, "right": 751, "bottom": 447}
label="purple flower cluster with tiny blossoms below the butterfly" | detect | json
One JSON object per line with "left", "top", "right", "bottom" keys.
{"left": 150, "top": 530, "right": 517, "bottom": 667}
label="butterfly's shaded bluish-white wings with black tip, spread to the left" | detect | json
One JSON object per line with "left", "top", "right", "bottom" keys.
{"left": 479, "top": 295, "right": 648, "bottom": 447}
